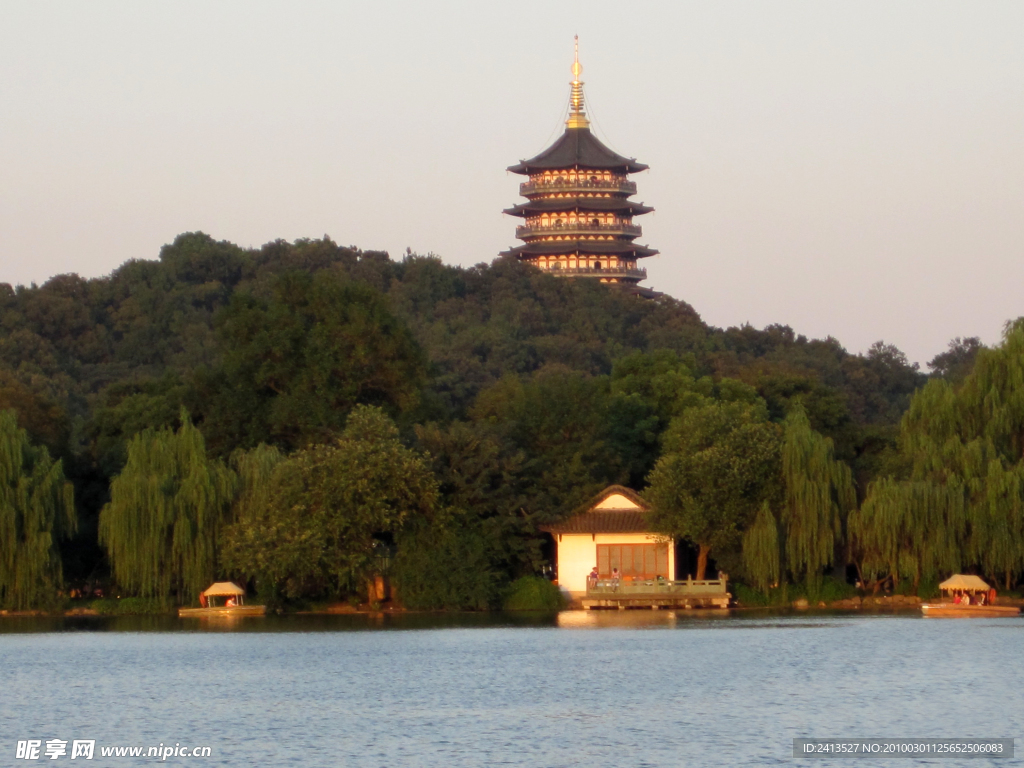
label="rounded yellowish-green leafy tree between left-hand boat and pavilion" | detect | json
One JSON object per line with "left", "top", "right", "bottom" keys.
{"left": 224, "top": 406, "right": 437, "bottom": 597}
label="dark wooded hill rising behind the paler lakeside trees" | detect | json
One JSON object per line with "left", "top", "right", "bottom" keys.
{"left": 0, "top": 232, "right": 942, "bottom": 593}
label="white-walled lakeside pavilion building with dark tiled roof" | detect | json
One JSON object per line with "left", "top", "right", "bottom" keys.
{"left": 541, "top": 485, "right": 676, "bottom": 599}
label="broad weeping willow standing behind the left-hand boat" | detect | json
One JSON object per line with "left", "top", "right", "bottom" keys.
{"left": 99, "top": 411, "right": 236, "bottom": 601}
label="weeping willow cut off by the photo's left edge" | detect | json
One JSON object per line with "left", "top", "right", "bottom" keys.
{"left": 0, "top": 411, "right": 76, "bottom": 610}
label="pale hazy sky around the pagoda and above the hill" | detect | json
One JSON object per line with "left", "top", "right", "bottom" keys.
{"left": 0, "top": 0, "right": 1024, "bottom": 365}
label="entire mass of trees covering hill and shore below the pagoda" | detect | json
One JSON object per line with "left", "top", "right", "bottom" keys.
{"left": 0, "top": 233, "right": 1007, "bottom": 608}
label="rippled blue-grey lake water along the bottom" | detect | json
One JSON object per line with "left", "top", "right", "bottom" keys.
{"left": 0, "top": 611, "right": 1024, "bottom": 768}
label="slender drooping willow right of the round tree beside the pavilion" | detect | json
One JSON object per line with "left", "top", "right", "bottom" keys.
{"left": 781, "top": 404, "right": 857, "bottom": 583}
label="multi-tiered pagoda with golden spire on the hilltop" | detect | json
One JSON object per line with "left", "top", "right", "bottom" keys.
{"left": 502, "top": 39, "right": 657, "bottom": 286}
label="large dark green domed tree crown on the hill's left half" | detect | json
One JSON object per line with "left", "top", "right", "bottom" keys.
{"left": 197, "top": 271, "right": 425, "bottom": 452}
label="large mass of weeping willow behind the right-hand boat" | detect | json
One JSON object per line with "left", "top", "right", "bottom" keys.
{"left": 850, "top": 321, "right": 1024, "bottom": 588}
